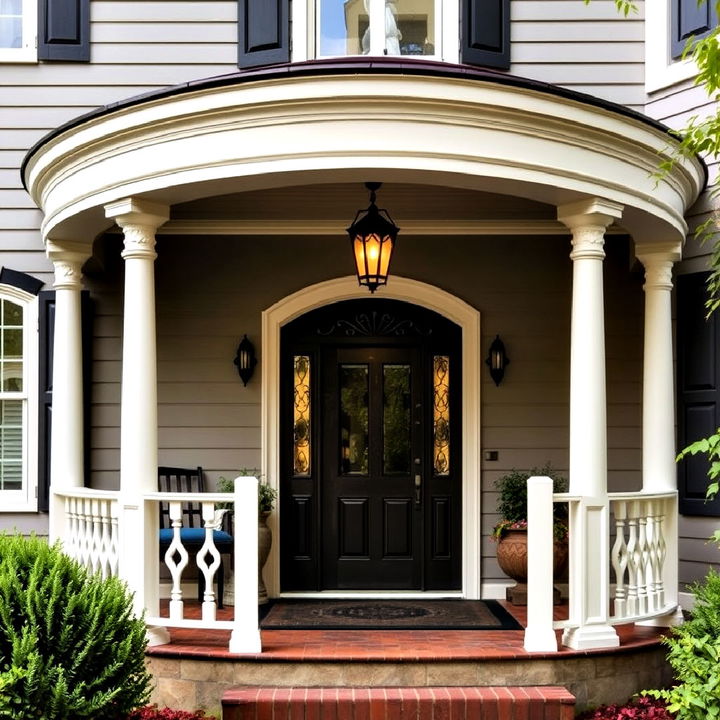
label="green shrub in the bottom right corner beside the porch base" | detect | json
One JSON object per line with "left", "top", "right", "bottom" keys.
{"left": 645, "top": 570, "right": 720, "bottom": 720}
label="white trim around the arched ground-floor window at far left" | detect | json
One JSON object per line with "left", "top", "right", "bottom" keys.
{"left": 0, "top": 285, "right": 38, "bottom": 513}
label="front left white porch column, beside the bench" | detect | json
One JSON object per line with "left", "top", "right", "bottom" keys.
{"left": 105, "top": 198, "right": 168, "bottom": 643}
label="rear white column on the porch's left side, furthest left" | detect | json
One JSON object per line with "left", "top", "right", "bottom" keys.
{"left": 47, "top": 240, "right": 90, "bottom": 541}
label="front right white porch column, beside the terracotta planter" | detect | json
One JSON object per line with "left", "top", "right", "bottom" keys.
{"left": 558, "top": 199, "right": 622, "bottom": 649}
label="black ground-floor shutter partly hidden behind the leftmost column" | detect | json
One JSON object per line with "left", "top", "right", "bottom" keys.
{"left": 38, "top": 290, "right": 93, "bottom": 512}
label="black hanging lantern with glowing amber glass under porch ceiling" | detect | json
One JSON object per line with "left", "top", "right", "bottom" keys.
{"left": 347, "top": 183, "right": 400, "bottom": 293}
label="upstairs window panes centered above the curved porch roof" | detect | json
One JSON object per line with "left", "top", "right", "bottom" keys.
{"left": 315, "top": 0, "right": 441, "bottom": 57}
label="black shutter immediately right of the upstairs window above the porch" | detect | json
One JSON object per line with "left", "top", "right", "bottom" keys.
{"left": 460, "top": 0, "right": 510, "bottom": 70}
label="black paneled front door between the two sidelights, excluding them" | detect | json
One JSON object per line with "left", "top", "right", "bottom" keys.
{"left": 320, "top": 346, "right": 424, "bottom": 590}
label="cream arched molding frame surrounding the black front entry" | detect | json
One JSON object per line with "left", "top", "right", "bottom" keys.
{"left": 260, "top": 275, "right": 482, "bottom": 599}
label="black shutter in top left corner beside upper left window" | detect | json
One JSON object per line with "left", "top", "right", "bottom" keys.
{"left": 38, "top": 0, "right": 90, "bottom": 62}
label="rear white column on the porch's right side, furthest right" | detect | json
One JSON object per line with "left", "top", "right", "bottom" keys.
{"left": 635, "top": 242, "right": 682, "bottom": 625}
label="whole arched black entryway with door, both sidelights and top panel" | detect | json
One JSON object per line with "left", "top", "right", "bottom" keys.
{"left": 280, "top": 299, "right": 462, "bottom": 592}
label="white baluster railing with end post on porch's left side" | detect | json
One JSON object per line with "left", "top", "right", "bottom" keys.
{"left": 53, "top": 477, "right": 261, "bottom": 653}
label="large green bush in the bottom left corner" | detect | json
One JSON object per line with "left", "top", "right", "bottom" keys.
{"left": 0, "top": 535, "right": 151, "bottom": 720}
